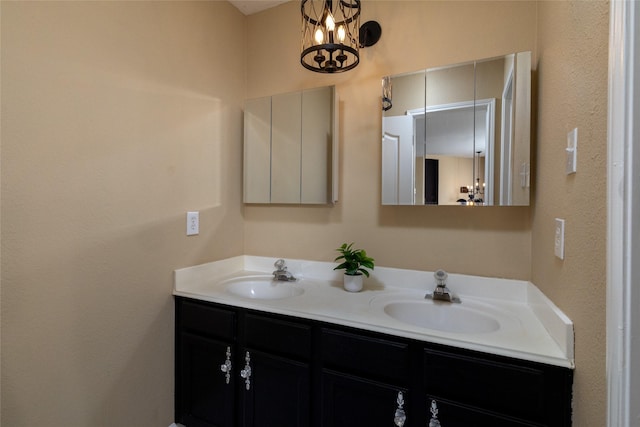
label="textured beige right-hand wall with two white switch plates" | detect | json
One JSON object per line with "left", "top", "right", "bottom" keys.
{"left": 532, "top": 1, "right": 609, "bottom": 427}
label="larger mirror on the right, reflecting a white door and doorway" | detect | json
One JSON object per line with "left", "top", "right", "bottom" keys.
{"left": 382, "top": 52, "right": 531, "bottom": 206}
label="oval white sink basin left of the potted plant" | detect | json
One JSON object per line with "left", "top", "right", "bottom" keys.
{"left": 225, "top": 276, "right": 304, "bottom": 299}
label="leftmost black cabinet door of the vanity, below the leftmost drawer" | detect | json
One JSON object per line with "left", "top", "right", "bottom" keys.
{"left": 176, "top": 334, "right": 235, "bottom": 427}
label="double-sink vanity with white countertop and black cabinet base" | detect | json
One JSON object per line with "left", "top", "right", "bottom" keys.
{"left": 174, "top": 257, "right": 573, "bottom": 427}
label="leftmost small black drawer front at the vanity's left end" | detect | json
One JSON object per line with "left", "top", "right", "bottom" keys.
{"left": 177, "top": 299, "right": 236, "bottom": 340}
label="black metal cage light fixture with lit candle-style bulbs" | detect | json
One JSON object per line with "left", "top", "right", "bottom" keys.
{"left": 300, "top": 0, "right": 382, "bottom": 73}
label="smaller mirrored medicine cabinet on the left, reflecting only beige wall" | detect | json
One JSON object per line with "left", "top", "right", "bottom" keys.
{"left": 243, "top": 86, "right": 338, "bottom": 204}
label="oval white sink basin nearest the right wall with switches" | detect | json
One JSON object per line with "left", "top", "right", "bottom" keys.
{"left": 384, "top": 300, "right": 500, "bottom": 334}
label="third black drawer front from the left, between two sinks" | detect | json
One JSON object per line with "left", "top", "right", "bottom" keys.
{"left": 322, "top": 328, "right": 410, "bottom": 384}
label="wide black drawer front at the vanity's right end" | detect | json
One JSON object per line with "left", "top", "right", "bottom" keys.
{"left": 424, "top": 349, "right": 572, "bottom": 425}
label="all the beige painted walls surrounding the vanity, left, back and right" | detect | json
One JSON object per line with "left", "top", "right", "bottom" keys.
{"left": 0, "top": 0, "right": 608, "bottom": 427}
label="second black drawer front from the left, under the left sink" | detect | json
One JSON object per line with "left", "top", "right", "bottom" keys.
{"left": 244, "top": 313, "right": 311, "bottom": 359}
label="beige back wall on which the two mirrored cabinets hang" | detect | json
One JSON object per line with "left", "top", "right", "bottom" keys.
{"left": 244, "top": 1, "right": 536, "bottom": 279}
